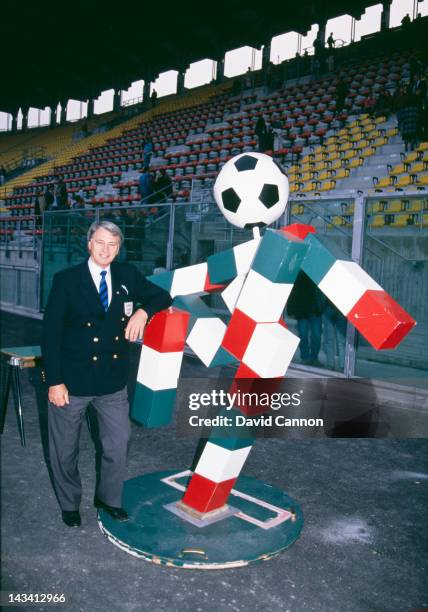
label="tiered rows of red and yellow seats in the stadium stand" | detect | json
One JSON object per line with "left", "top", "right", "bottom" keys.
{"left": 0, "top": 46, "right": 428, "bottom": 241}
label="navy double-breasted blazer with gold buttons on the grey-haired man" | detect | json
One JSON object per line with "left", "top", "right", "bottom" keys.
{"left": 42, "top": 261, "right": 171, "bottom": 396}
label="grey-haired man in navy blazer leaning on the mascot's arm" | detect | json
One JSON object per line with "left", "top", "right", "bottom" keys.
{"left": 42, "top": 221, "right": 171, "bottom": 527}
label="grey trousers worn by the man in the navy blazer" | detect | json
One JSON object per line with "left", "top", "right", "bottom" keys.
{"left": 48, "top": 389, "right": 131, "bottom": 510}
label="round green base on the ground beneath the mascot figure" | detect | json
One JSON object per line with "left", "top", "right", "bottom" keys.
{"left": 98, "top": 471, "right": 303, "bottom": 570}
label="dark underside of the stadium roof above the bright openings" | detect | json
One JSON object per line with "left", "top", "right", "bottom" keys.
{"left": 0, "top": 0, "right": 375, "bottom": 112}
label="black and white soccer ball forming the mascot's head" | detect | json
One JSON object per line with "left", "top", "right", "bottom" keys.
{"left": 214, "top": 152, "right": 289, "bottom": 228}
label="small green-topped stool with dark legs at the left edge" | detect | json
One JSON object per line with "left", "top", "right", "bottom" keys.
{"left": 0, "top": 346, "right": 42, "bottom": 446}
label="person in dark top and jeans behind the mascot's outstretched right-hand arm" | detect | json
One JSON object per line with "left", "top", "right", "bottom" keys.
{"left": 287, "top": 272, "right": 322, "bottom": 365}
